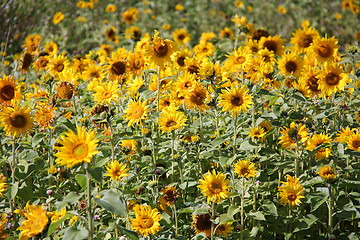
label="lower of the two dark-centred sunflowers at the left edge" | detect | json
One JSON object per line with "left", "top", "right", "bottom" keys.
{"left": 0, "top": 105, "right": 33, "bottom": 137}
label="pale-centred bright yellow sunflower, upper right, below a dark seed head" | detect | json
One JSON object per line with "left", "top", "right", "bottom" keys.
{"left": 224, "top": 47, "right": 252, "bottom": 72}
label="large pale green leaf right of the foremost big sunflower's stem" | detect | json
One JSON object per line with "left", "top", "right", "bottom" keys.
{"left": 94, "top": 190, "right": 126, "bottom": 217}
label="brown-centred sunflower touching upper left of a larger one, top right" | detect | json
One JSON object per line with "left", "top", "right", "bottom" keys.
{"left": 290, "top": 26, "right": 319, "bottom": 53}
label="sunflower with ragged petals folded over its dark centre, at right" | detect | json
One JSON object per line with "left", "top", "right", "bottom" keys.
{"left": 279, "top": 122, "right": 309, "bottom": 149}
